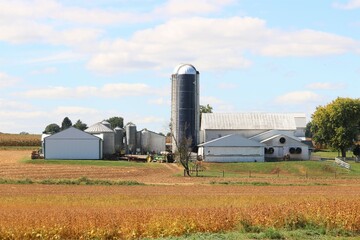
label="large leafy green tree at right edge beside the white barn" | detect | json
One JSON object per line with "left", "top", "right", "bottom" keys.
{"left": 311, "top": 97, "right": 360, "bottom": 157}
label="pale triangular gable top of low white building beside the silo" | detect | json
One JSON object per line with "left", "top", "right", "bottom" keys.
{"left": 199, "top": 134, "right": 265, "bottom": 147}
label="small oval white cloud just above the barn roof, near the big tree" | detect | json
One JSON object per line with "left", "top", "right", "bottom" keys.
{"left": 275, "top": 91, "right": 321, "bottom": 105}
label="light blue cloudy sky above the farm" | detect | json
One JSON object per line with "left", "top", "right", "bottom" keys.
{"left": 0, "top": 0, "right": 360, "bottom": 134}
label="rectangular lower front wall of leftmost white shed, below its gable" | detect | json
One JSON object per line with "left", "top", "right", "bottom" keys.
{"left": 44, "top": 139, "right": 102, "bottom": 159}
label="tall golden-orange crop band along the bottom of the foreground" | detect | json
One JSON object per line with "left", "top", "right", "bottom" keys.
{"left": 0, "top": 197, "right": 360, "bottom": 239}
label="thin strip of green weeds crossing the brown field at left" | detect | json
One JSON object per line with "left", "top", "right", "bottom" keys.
{"left": 0, "top": 177, "right": 145, "bottom": 186}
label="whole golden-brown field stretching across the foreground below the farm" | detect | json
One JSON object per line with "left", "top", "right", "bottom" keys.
{"left": 0, "top": 150, "right": 360, "bottom": 239}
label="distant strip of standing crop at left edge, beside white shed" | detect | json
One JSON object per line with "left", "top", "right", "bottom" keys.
{"left": 0, "top": 134, "right": 41, "bottom": 147}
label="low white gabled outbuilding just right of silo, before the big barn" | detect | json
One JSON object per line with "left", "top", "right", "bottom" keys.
{"left": 198, "top": 134, "right": 265, "bottom": 162}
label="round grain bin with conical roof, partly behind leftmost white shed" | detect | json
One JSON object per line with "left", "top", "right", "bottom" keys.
{"left": 85, "top": 122, "right": 115, "bottom": 154}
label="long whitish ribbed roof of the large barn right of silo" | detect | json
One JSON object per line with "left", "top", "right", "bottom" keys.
{"left": 201, "top": 113, "right": 306, "bottom": 130}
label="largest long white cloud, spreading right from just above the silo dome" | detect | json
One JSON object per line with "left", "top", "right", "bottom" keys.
{"left": 88, "top": 17, "right": 360, "bottom": 73}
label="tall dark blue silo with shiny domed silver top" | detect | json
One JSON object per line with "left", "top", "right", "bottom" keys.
{"left": 171, "top": 64, "right": 200, "bottom": 152}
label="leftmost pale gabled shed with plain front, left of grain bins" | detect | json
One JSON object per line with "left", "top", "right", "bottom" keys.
{"left": 43, "top": 127, "right": 102, "bottom": 159}
